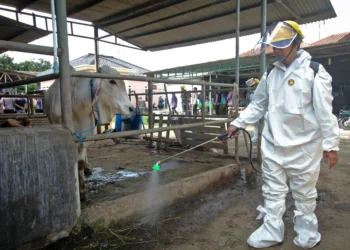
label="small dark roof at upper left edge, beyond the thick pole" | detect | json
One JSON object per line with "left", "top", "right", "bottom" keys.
{"left": 0, "top": 16, "right": 50, "bottom": 53}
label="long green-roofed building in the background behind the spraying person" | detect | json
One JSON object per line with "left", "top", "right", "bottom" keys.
{"left": 147, "top": 32, "right": 350, "bottom": 106}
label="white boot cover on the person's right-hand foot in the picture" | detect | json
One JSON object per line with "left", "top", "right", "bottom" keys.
{"left": 293, "top": 201, "right": 321, "bottom": 249}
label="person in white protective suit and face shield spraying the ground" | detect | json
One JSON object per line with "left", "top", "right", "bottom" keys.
{"left": 227, "top": 21, "right": 339, "bottom": 248}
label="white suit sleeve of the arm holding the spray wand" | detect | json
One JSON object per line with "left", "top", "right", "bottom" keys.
{"left": 231, "top": 72, "right": 269, "bottom": 128}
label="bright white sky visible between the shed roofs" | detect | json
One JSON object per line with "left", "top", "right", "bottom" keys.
{"left": 0, "top": 0, "right": 350, "bottom": 71}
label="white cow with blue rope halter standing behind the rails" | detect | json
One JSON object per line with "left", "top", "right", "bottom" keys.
{"left": 44, "top": 66, "right": 134, "bottom": 200}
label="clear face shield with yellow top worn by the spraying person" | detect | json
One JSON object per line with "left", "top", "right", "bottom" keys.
{"left": 254, "top": 22, "right": 298, "bottom": 55}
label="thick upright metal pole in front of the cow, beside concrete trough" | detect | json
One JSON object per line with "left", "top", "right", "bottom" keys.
{"left": 55, "top": 0, "right": 74, "bottom": 131}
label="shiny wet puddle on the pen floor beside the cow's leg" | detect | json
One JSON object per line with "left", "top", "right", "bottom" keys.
{"left": 85, "top": 167, "right": 147, "bottom": 188}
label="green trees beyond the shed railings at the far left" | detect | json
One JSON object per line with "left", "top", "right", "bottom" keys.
{"left": 0, "top": 54, "right": 52, "bottom": 93}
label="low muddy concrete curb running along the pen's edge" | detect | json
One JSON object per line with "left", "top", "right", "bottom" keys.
{"left": 81, "top": 164, "right": 240, "bottom": 230}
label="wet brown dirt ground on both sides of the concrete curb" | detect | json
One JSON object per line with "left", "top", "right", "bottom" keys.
{"left": 46, "top": 132, "right": 350, "bottom": 250}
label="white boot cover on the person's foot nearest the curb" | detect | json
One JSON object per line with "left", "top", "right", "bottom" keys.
{"left": 247, "top": 200, "right": 286, "bottom": 248}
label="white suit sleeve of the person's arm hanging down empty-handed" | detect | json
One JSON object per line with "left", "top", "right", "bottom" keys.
{"left": 313, "top": 65, "right": 339, "bottom": 151}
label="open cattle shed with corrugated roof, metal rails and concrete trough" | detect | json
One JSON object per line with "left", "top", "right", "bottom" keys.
{"left": 0, "top": 0, "right": 336, "bottom": 249}
